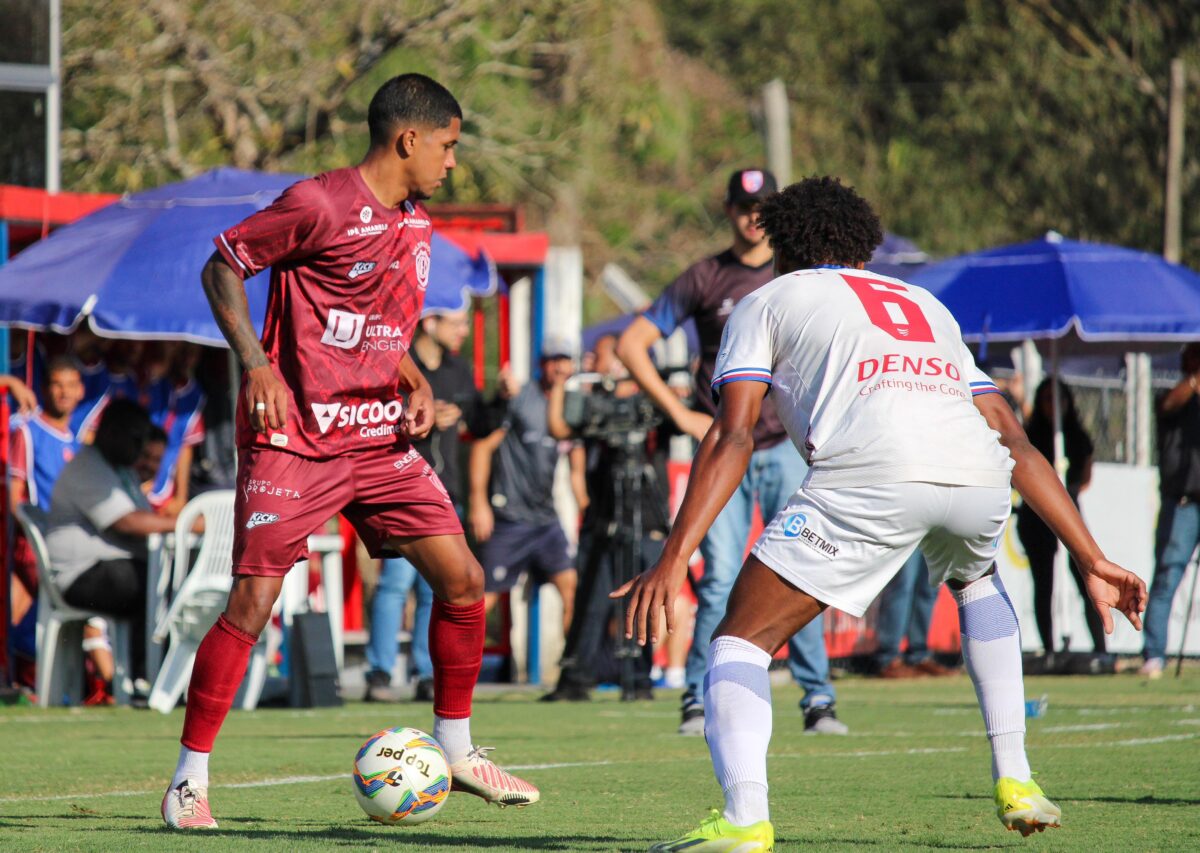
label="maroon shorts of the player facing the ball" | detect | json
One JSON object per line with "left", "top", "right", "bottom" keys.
{"left": 233, "top": 447, "right": 462, "bottom": 575}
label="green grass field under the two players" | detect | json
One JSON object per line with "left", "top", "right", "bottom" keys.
{"left": 0, "top": 669, "right": 1200, "bottom": 853}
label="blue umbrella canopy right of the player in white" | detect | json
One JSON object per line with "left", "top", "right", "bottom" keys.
{"left": 908, "top": 233, "right": 1200, "bottom": 350}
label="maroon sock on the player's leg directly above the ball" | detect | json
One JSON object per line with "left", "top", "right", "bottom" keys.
{"left": 430, "top": 599, "right": 486, "bottom": 720}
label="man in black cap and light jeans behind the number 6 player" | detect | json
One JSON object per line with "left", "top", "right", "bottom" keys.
{"left": 617, "top": 169, "right": 847, "bottom": 734}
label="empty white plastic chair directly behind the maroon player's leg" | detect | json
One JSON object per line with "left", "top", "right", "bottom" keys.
{"left": 150, "top": 489, "right": 266, "bottom": 714}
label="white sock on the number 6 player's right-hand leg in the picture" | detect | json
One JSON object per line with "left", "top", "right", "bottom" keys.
{"left": 950, "top": 573, "right": 1031, "bottom": 782}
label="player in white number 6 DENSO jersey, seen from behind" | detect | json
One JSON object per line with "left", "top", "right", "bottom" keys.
{"left": 613, "top": 178, "right": 1146, "bottom": 853}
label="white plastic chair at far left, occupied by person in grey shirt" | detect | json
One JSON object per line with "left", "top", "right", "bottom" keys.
{"left": 17, "top": 504, "right": 133, "bottom": 708}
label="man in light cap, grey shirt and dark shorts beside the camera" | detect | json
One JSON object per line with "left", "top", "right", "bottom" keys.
{"left": 468, "top": 337, "right": 587, "bottom": 632}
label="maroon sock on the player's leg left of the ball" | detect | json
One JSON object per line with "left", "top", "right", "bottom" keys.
{"left": 180, "top": 613, "right": 258, "bottom": 752}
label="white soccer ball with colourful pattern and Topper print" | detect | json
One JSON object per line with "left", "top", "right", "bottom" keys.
{"left": 354, "top": 727, "right": 450, "bottom": 823}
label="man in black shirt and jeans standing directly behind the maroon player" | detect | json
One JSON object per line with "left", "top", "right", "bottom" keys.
{"left": 365, "top": 310, "right": 488, "bottom": 702}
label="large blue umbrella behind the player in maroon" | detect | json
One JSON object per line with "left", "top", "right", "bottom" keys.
{"left": 0, "top": 169, "right": 496, "bottom": 347}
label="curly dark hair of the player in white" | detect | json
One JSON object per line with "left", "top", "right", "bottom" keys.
{"left": 758, "top": 175, "right": 883, "bottom": 271}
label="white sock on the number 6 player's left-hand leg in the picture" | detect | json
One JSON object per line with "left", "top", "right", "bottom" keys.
{"left": 704, "top": 637, "right": 772, "bottom": 827}
